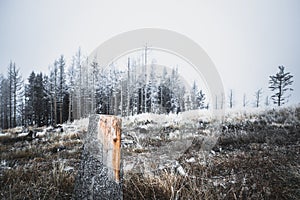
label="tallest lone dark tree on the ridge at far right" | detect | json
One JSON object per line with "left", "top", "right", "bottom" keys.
{"left": 269, "top": 66, "right": 293, "bottom": 106}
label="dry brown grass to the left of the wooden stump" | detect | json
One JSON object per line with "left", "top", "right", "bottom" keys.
{"left": 0, "top": 130, "right": 82, "bottom": 199}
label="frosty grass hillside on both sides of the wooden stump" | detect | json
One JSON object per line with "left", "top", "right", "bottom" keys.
{"left": 0, "top": 107, "right": 300, "bottom": 199}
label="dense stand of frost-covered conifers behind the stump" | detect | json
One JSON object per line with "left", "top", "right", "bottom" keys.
{"left": 0, "top": 49, "right": 209, "bottom": 129}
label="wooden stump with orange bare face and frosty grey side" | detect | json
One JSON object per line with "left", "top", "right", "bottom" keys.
{"left": 74, "top": 115, "right": 123, "bottom": 199}
